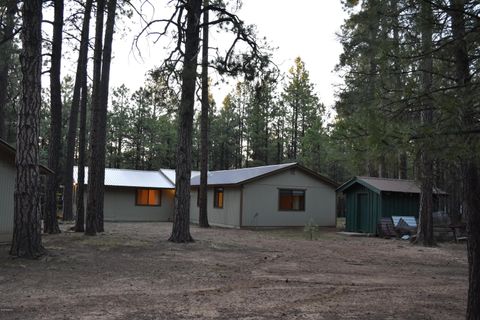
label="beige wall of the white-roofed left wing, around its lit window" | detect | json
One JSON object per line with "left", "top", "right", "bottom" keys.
{"left": 78, "top": 187, "right": 175, "bottom": 222}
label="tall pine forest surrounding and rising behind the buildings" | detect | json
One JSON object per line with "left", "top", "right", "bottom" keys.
{"left": 0, "top": 0, "right": 480, "bottom": 319}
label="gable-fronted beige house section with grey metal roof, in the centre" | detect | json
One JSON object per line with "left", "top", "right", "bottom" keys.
{"left": 190, "top": 163, "right": 337, "bottom": 228}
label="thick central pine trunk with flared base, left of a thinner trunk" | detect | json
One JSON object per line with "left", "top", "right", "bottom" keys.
{"left": 168, "top": 0, "right": 202, "bottom": 242}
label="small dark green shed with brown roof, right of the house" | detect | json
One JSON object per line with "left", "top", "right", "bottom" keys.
{"left": 337, "top": 177, "right": 446, "bottom": 234}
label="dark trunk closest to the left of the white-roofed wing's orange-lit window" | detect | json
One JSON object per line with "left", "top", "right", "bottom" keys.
{"left": 85, "top": 0, "right": 117, "bottom": 235}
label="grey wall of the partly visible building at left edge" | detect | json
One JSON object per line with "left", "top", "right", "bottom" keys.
{"left": 0, "top": 157, "right": 15, "bottom": 242}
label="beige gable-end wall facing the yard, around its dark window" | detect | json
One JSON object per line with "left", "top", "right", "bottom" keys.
{"left": 242, "top": 169, "right": 336, "bottom": 227}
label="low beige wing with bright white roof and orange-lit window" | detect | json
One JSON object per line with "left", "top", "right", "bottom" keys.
{"left": 73, "top": 167, "right": 188, "bottom": 221}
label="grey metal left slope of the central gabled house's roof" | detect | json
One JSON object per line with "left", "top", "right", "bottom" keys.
{"left": 191, "top": 162, "right": 297, "bottom": 186}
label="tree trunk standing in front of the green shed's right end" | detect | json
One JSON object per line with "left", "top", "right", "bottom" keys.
{"left": 416, "top": 2, "right": 435, "bottom": 246}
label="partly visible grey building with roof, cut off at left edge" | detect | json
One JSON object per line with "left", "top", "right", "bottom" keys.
{"left": 0, "top": 139, "right": 53, "bottom": 242}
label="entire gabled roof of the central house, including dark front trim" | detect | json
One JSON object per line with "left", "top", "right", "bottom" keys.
{"left": 191, "top": 162, "right": 338, "bottom": 188}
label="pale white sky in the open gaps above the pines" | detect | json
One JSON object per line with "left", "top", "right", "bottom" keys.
{"left": 111, "top": 0, "right": 346, "bottom": 107}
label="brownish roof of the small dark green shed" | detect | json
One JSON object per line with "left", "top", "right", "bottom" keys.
{"left": 337, "top": 177, "right": 445, "bottom": 194}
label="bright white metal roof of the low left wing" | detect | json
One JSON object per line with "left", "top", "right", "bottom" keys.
{"left": 73, "top": 166, "right": 175, "bottom": 189}
